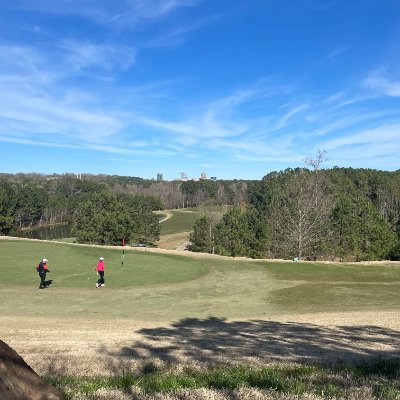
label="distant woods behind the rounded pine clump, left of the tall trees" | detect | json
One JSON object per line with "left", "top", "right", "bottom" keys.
{"left": 0, "top": 174, "right": 247, "bottom": 234}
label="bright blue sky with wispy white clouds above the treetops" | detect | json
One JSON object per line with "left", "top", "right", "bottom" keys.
{"left": 0, "top": 0, "right": 400, "bottom": 180}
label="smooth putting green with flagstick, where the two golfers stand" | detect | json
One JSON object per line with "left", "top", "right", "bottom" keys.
{"left": 0, "top": 240, "right": 207, "bottom": 287}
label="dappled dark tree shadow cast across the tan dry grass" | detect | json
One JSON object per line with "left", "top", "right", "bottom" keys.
{"left": 113, "top": 317, "right": 400, "bottom": 365}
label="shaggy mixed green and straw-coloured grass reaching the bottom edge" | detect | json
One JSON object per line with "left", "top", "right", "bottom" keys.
{"left": 48, "top": 359, "right": 400, "bottom": 400}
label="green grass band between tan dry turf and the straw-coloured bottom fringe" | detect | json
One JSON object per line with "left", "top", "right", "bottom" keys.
{"left": 46, "top": 359, "right": 400, "bottom": 400}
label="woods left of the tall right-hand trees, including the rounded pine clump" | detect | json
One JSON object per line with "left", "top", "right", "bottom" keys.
{"left": 0, "top": 173, "right": 247, "bottom": 244}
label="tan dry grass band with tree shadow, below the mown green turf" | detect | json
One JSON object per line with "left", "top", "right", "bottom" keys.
{"left": 0, "top": 312, "right": 400, "bottom": 375}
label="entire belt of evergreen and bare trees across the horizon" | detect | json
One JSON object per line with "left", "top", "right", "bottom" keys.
{"left": 0, "top": 167, "right": 400, "bottom": 261}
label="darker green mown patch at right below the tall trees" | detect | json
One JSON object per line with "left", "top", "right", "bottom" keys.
{"left": 268, "top": 263, "right": 400, "bottom": 313}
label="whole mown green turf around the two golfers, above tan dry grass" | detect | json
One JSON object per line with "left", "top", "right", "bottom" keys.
{"left": 0, "top": 240, "right": 400, "bottom": 321}
